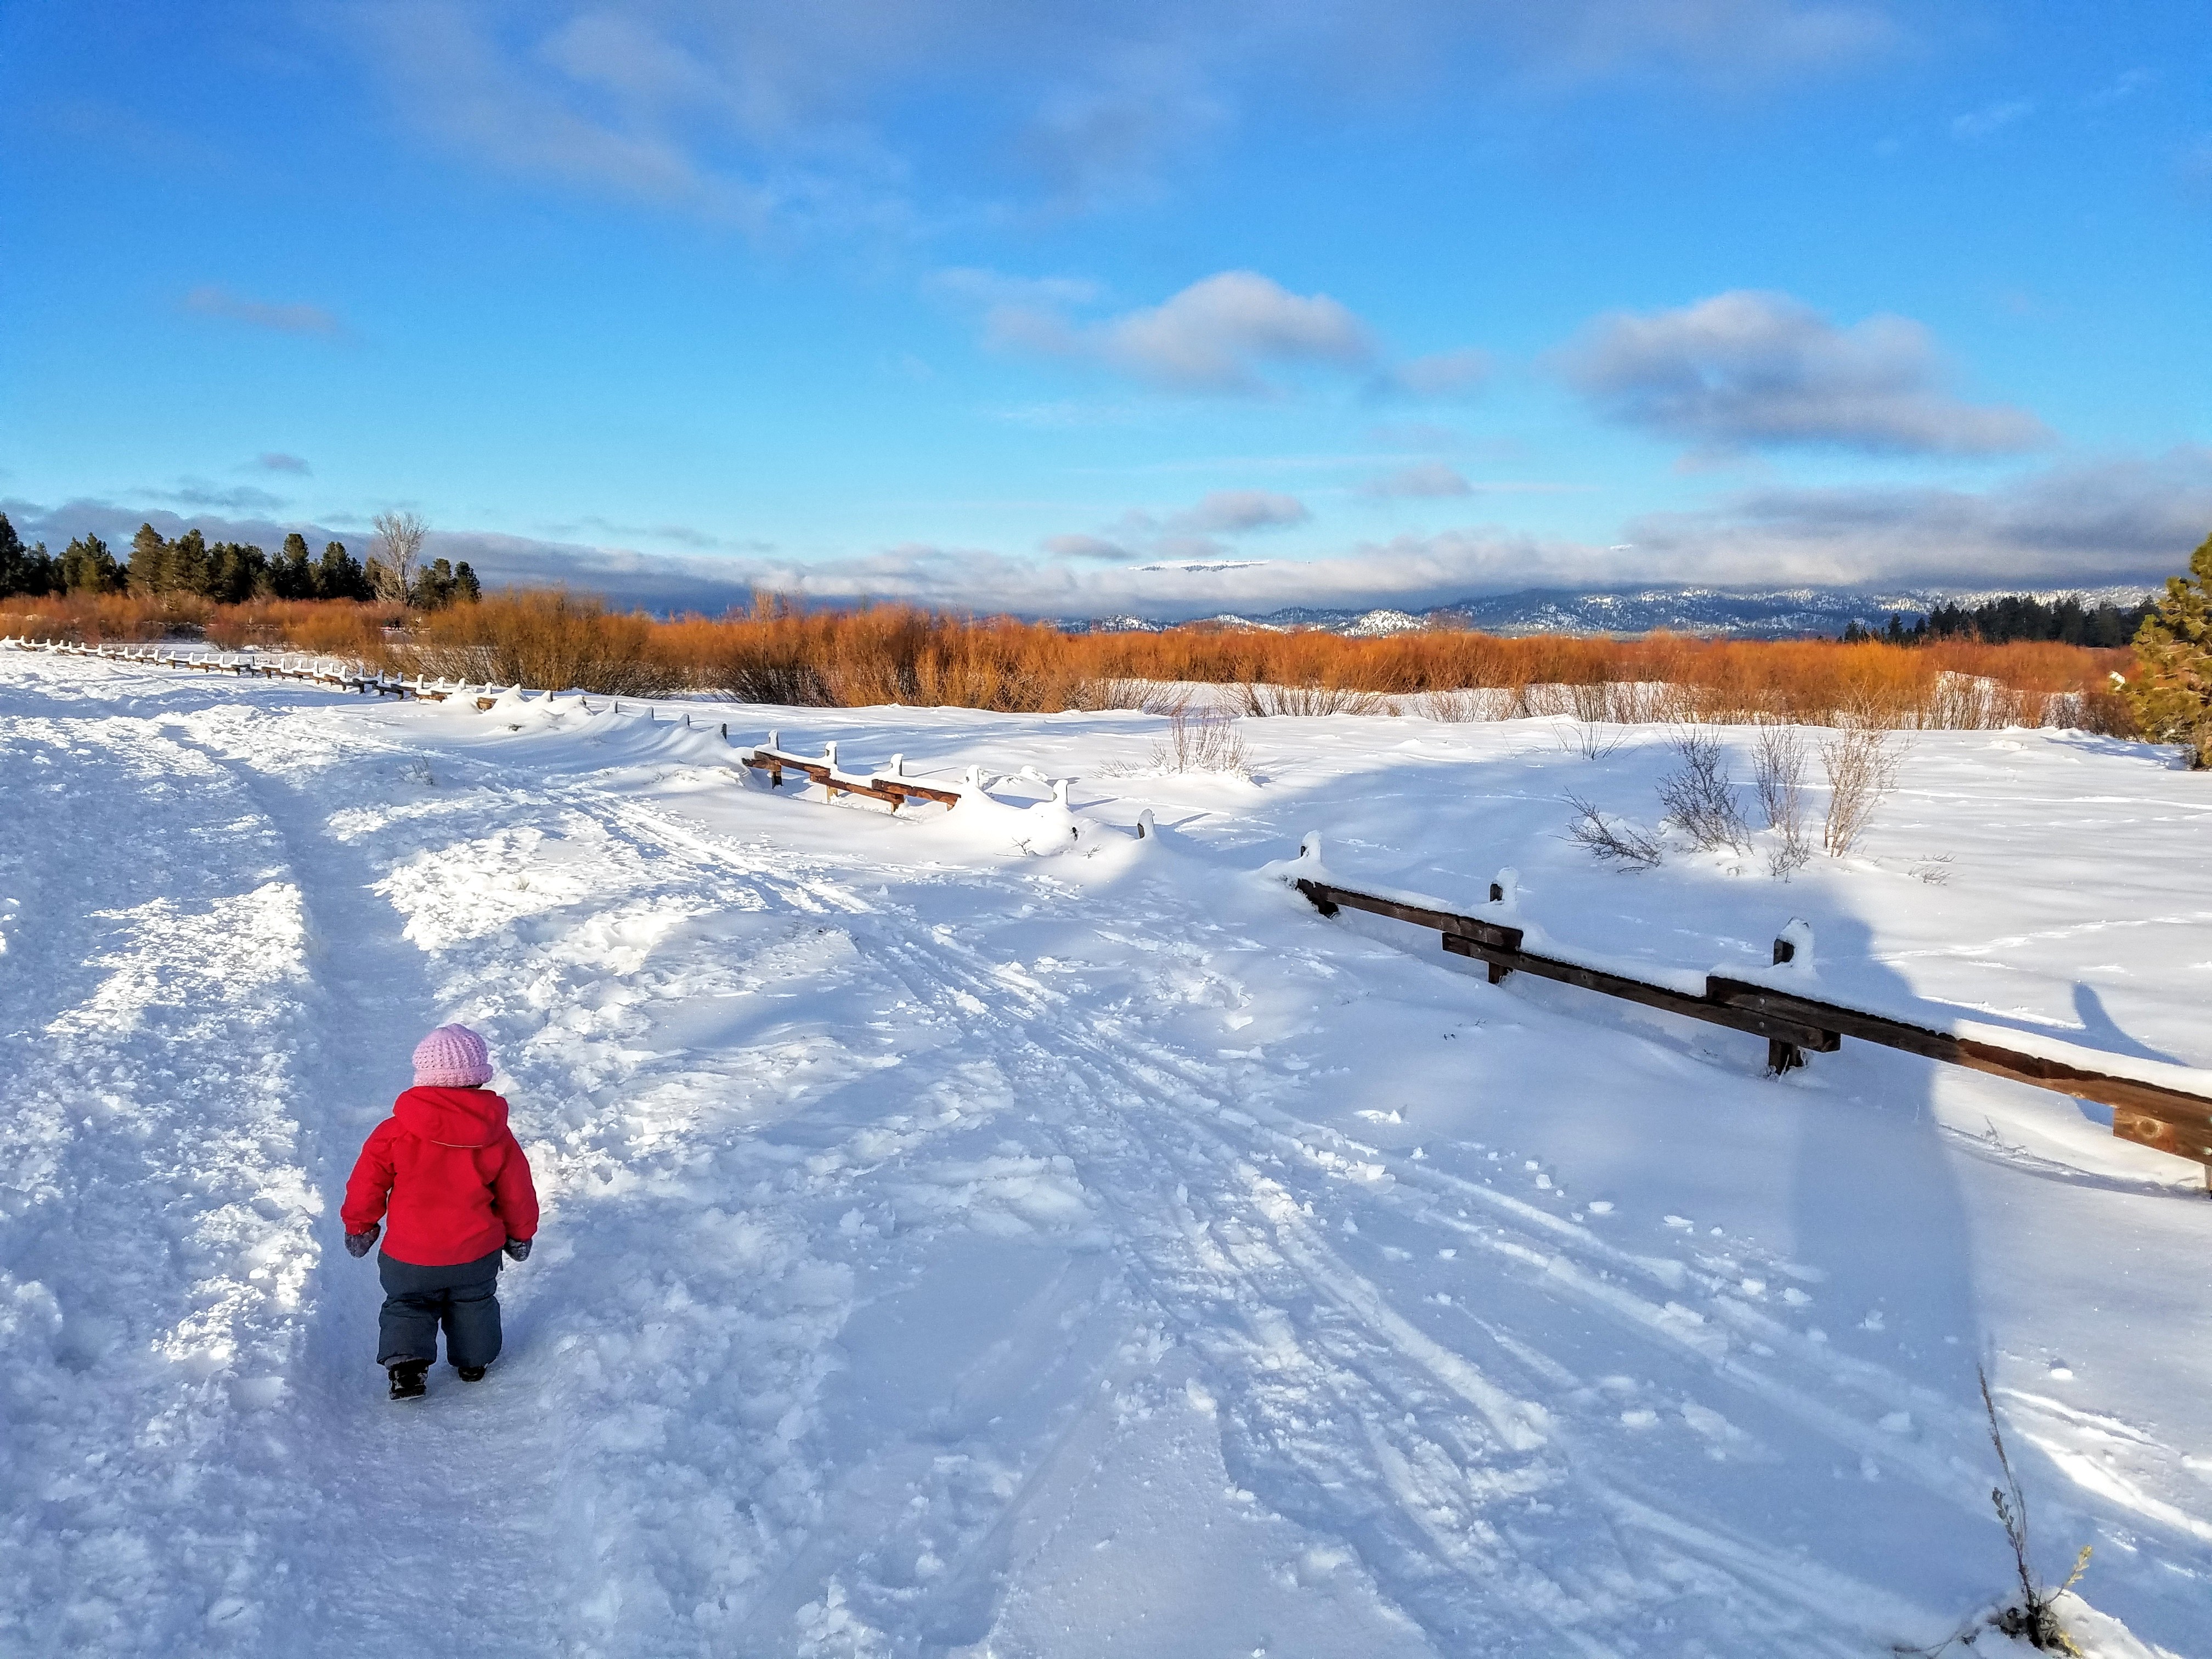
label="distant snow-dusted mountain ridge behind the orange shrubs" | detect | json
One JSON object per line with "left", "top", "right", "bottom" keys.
{"left": 1059, "top": 582, "right": 2154, "bottom": 639}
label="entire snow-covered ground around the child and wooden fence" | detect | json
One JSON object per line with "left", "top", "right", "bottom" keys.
{"left": 0, "top": 652, "right": 2212, "bottom": 1659}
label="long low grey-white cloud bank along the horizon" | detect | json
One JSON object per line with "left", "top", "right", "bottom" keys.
{"left": 0, "top": 447, "right": 2212, "bottom": 619}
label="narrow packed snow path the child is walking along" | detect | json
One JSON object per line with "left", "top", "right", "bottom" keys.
{"left": 168, "top": 721, "right": 575, "bottom": 1655}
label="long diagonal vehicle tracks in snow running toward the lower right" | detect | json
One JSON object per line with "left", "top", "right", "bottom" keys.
{"left": 363, "top": 747, "right": 1973, "bottom": 1652}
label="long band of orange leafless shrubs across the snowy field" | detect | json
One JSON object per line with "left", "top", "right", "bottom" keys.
{"left": 0, "top": 591, "right": 2130, "bottom": 732}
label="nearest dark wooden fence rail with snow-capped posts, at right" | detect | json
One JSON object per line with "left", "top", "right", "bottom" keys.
{"left": 1272, "top": 836, "right": 2212, "bottom": 1194}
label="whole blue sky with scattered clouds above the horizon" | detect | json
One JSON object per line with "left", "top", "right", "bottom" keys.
{"left": 0, "top": 0, "right": 2212, "bottom": 615}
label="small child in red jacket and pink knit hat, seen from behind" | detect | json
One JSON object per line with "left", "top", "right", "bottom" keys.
{"left": 338, "top": 1026, "right": 538, "bottom": 1400}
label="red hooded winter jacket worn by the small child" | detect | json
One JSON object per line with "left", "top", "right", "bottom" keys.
{"left": 338, "top": 1088, "right": 538, "bottom": 1267}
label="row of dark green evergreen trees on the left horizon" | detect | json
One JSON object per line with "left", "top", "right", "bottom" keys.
{"left": 0, "top": 513, "right": 482, "bottom": 611}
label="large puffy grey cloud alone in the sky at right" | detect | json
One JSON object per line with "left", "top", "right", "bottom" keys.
{"left": 1560, "top": 290, "right": 2051, "bottom": 456}
